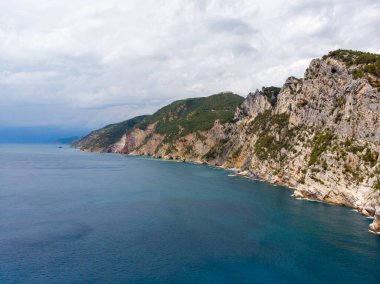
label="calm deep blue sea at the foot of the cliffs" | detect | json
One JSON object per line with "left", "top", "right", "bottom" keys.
{"left": 0, "top": 145, "right": 380, "bottom": 283}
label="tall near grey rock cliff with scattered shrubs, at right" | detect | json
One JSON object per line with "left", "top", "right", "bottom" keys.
{"left": 219, "top": 55, "right": 380, "bottom": 231}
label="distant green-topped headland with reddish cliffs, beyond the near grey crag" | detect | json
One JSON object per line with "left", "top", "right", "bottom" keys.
{"left": 74, "top": 92, "right": 244, "bottom": 162}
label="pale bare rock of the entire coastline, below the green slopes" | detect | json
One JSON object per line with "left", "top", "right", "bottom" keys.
{"left": 77, "top": 52, "right": 380, "bottom": 231}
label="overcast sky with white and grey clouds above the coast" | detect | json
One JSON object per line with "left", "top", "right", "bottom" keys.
{"left": 0, "top": 0, "right": 380, "bottom": 128}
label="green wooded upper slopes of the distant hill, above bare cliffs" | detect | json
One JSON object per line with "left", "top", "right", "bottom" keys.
{"left": 73, "top": 92, "right": 244, "bottom": 151}
